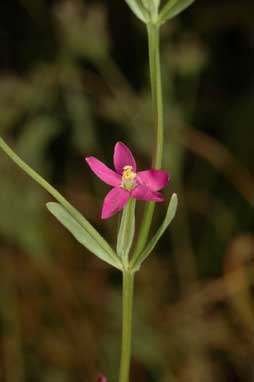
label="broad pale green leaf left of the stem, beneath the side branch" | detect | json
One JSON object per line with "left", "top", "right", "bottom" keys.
{"left": 47, "top": 202, "right": 122, "bottom": 269}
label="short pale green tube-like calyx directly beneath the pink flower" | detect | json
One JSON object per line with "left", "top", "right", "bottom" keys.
{"left": 117, "top": 199, "right": 136, "bottom": 260}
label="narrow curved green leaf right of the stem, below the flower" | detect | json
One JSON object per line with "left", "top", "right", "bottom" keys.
{"left": 131, "top": 194, "right": 178, "bottom": 269}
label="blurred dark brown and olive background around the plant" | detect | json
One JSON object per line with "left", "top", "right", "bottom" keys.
{"left": 0, "top": 0, "right": 254, "bottom": 382}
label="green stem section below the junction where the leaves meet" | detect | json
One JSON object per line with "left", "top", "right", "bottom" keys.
{"left": 119, "top": 270, "right": 134, "bottom": 382}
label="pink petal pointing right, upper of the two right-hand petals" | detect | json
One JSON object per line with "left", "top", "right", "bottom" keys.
{"left": 137, "top": 170, "right": 170, "bottom": 191}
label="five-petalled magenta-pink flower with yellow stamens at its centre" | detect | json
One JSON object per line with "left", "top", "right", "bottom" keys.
{"left": 86, "top": 142, "right": 169, "bottom": 219}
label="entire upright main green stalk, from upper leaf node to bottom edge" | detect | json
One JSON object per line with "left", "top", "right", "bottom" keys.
{"left": 119, "top": 22, "right": 163, "bottom": 382}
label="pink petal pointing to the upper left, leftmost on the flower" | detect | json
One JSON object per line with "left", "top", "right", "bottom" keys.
{"left": 86, "top": 157, "right": 121, "bottom": 187}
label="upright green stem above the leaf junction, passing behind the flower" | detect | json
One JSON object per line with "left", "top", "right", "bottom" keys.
{"left": 133, "top": 22, "right": 164, "bottom": 259}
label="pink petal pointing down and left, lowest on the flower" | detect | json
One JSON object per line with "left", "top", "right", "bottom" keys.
{"left": 101, "top": 187, "right": 130, "bottom": 219}
